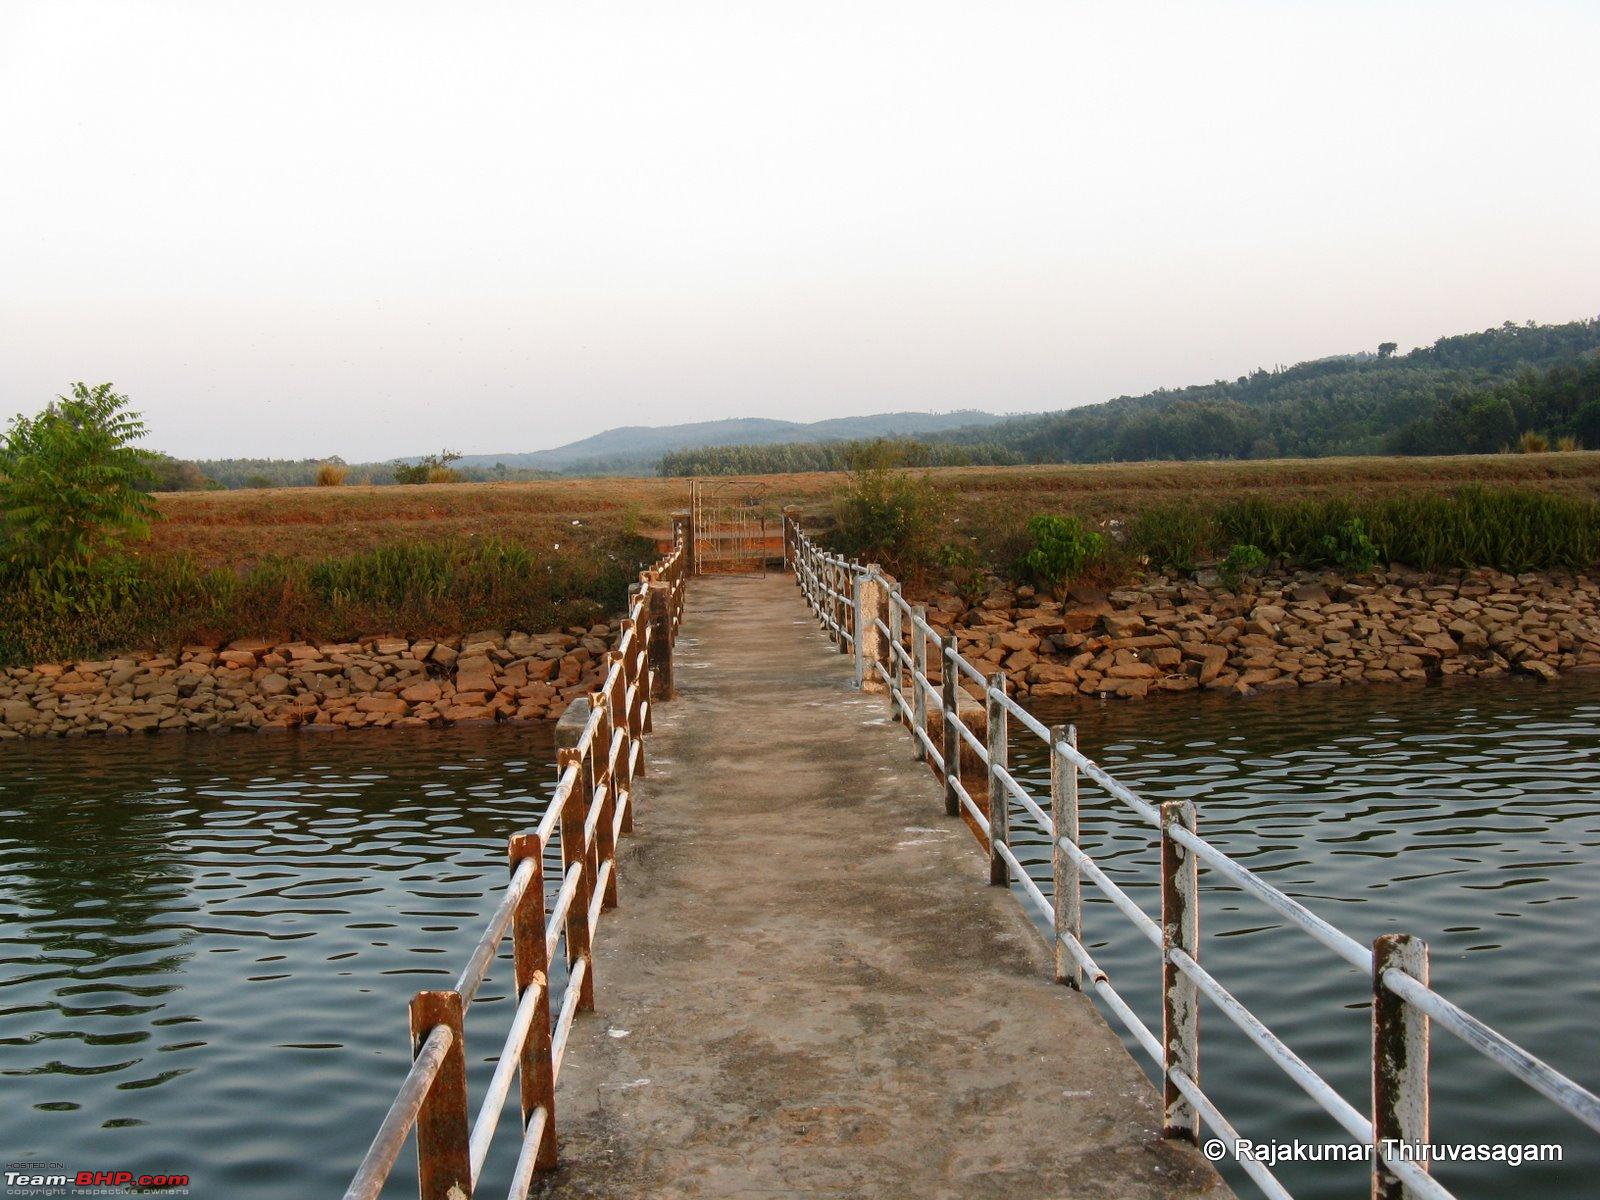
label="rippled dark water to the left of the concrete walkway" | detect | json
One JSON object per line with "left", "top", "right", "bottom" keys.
{"left": 0, "top": 725, "right": 554, "bottom": 1200}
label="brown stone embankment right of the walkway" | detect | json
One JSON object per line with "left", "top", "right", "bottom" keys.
{"left": 928, "top": 570, "right": 1600, "bottom": 699}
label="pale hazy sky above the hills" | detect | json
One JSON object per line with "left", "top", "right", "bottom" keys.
{"left": 0, "top": 0, "right": 1600, "bottom": 459}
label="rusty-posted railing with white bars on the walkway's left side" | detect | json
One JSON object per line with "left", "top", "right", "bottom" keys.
{"left": 344, "top": 531, "right": 686, "bottom": 1200}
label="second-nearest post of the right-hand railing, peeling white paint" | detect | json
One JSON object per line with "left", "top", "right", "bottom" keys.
{"left": 1162, "top": 800, "right": 1200, "bottom": 1142}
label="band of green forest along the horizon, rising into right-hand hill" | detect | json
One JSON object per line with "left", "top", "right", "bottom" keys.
{"left": 158, "top": 320, "right": 1600, "bottom": 490}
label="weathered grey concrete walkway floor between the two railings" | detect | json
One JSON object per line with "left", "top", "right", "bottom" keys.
{"left": 538, "top": 573, "right": 1230, "bottom": 1200}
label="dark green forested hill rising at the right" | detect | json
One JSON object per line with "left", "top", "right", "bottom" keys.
{"left": 953, "top": 320, "right": 1600, "bottom": 462}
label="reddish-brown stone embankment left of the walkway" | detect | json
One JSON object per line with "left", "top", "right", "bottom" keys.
{"left": 0, "top": 624, "right": 613, "bottom": 738}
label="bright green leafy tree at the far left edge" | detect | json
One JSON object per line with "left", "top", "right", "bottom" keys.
{"left": 0, "top": 382, "right": 155, "bottom": 581}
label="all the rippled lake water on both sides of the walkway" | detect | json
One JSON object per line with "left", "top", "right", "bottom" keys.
{"left": 0, "top": 680, "right": 1600, "bottom": 1200}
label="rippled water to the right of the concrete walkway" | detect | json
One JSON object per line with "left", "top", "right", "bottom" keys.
{"left": 1011, "top": 678, "right": 1600, "bottom": 1198}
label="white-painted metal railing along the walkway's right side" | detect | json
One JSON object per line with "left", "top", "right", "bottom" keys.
{"left": 784, "top": 514, "right": 1600, "bottom": 1200}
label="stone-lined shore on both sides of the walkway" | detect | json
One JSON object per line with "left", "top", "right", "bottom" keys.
{"left": 0, "top": 566, "right": 1600, "bottom": 741}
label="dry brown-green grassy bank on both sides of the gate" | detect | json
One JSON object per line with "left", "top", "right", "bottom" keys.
{"left": 18, "top": 453, "right": 1600, "bottom": 666}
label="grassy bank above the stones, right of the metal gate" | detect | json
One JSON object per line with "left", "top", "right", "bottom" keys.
{"left": 812, "top": 453, "right": 1600, "bottom": 590}
